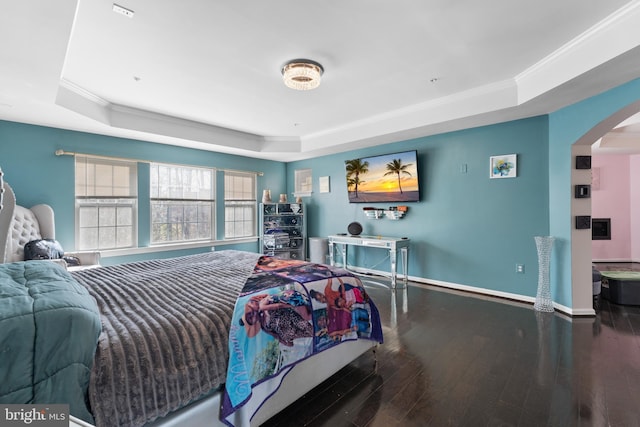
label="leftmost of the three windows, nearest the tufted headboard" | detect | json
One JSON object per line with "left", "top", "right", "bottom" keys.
{"left": 75, "top": 156, "right": 138, "bottom": 250}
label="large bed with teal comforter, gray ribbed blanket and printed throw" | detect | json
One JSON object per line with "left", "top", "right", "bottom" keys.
{"left": 0, "top": 251, "right": 382, "bottom": 427}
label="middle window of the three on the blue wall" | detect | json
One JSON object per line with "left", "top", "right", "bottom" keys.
{"left": 150, "top": 163, "right": 215, "bottom": 244}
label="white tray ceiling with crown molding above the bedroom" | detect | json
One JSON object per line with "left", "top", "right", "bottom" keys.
{"left": 0, "top": 0, "right": 640, "bottom": 161}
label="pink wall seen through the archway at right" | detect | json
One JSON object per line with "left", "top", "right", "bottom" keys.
{"left": 591, "top": 154, "right": 640, "bottom": 261}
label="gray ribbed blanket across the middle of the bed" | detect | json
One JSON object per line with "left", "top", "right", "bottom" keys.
{"left": 70, "top": 251, "right": 260, "bottom": 427}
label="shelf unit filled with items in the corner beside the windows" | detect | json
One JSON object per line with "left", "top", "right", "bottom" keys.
{"left": 260, "top": 203, "right": 307, "bottom": 261}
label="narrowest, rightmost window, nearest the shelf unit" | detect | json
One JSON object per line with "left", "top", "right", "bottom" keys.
{"left": 224, "top": 171, "right": 257, "bottom": 239}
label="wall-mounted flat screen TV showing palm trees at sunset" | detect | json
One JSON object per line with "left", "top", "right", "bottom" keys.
{"left": 345, "top": 150, "right": 420, "bottom": 203}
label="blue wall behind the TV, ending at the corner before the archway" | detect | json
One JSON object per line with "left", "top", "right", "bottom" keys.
{"left": 287, "top": 117, "right": 549, "bottom": 296}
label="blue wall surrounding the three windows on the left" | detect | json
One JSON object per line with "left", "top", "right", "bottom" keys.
{"left": 0, "top": 121, "right": 286, "bottom": 264}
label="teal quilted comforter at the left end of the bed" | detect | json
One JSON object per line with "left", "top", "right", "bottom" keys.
{"left": 0, "top": 261, "right": 101, "bottom": 421}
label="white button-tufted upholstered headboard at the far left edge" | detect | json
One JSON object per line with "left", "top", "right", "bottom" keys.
{"left": 0, "top": 182, "right": 56, "bottom": 262}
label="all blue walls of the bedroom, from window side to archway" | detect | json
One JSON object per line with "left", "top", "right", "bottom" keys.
{"left": 0, "top": 80, "right": 640, "bottom": 307}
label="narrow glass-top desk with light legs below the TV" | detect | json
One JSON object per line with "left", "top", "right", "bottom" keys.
{"left": 327, "top": 234, "right": 410, "bottom": 289}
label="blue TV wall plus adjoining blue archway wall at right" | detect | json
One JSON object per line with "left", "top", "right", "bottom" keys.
{"left": 287, "top": 79, "right": 640, "bottom": 307}
